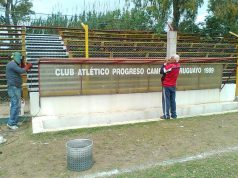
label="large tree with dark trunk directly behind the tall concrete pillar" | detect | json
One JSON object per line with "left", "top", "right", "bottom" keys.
{"left": 127, "top": 0, "right": 203, "bottom": 30}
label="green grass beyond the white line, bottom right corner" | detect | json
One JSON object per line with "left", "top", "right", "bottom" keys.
{"left": 116, "top": 152, "right": 238, "bottom": 178}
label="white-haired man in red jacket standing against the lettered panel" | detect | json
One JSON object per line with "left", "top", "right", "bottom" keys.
{"left": 160, "top": 54, "right": 180, "bottom": 119}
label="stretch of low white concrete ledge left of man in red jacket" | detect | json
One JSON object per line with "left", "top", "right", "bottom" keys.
{"left": 32, "top": 108, "right": 162, "bottom": 133}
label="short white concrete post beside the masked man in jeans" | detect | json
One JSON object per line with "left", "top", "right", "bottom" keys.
{"left": 30, "top": 92, "right": 40, "bottom": 116}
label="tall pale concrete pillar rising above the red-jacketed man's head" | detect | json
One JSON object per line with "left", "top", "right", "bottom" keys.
{"left": 167, "top": 31, "right": 177, "bottom": 58}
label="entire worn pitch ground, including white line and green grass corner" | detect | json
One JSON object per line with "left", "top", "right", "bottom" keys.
{"left": 0, "top": 113, "right": 238, "bottom": 178}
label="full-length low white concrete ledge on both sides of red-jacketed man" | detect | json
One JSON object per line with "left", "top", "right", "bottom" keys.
{"left": 32, "top": 102, "right": 238, "bottom": 133}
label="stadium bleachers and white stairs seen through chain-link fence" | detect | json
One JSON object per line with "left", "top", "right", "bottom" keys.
{"left": 0, "top": 25, "right": 238, "bottom": 116}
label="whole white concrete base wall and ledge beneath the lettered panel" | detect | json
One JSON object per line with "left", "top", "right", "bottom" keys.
{"left": 30, "top": 84, "right": 238, "bottom": 133}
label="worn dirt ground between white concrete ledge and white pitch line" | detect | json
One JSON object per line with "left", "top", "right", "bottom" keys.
{"left": 0, "top": 113, "right": 238, "bottom": 178}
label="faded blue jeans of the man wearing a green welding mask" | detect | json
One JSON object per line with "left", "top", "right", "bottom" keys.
{"left": 7, "top": 86, "right": 22, "bottom": 126}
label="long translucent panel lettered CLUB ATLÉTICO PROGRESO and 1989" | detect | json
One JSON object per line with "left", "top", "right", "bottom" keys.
{"left": 39, "top": 63, "right": 223, "bottom": 96}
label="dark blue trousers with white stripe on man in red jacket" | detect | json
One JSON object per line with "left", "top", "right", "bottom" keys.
{"left": 162, "top": 87, "right": 177, "bottom": 118}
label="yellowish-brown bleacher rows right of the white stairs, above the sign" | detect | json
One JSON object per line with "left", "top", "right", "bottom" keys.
{"left": 60, "top": 29, "right": 238, "bottom": 83}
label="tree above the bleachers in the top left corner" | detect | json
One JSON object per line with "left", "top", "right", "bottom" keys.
{"left": 0, "top": 0, "right": 34, "bottom": 25}
